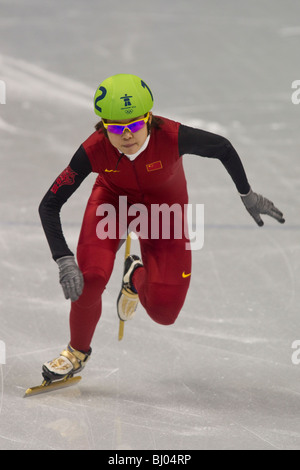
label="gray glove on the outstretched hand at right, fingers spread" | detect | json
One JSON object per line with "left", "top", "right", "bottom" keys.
{"left": 241, "top": 189, "right": 285, "bottom": 227}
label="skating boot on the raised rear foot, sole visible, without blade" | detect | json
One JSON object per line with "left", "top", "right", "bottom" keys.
{"left": 117, "top": 255, "right": 143, "bottom": 321}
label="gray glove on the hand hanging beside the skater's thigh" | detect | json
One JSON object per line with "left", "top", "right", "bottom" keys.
{"left": 56, "top": 256, "right": 84, "bottom": 302}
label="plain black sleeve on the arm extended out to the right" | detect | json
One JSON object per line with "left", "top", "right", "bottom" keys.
{"left": 178, "top": 124, "right": 250, "bottom": 194}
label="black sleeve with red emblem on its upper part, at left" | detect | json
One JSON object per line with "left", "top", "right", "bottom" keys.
{"left": 39, "top": 146, "right": 92, "bottom": 260}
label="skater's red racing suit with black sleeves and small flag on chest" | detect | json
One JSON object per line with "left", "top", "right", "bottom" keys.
{"left": 40, "top": 118, "right": 250, "bottom": 351}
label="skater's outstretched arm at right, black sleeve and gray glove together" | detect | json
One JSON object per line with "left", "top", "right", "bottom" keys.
{"left": 178, "top": 124, "right": 285, "bottom": 227}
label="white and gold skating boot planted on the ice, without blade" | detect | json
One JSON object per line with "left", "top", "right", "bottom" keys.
{"left": 42, "top": 344, "right": 92, "bottom": 382}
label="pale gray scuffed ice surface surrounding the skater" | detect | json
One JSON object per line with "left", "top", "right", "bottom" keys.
{"left": 0, "top": 0, "right": 300, "bottom": 450}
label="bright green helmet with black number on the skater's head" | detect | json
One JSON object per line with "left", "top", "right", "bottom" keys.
{"left": 94, "top": 73, "right": 153, "bottom": 121}
